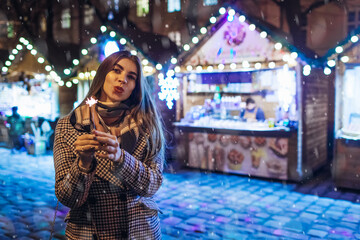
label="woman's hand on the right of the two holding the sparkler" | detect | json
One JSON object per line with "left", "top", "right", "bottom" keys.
{"left": 93, "top": 130, "right": 122, "bottom": 162}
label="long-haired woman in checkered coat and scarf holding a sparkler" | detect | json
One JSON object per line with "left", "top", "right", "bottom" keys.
{"left": 54, "top": 51, "right": 164, "bottom": 239}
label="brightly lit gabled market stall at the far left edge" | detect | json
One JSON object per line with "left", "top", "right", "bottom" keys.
{"left": 0, "top": 37, "right": 60, "bottom": 154}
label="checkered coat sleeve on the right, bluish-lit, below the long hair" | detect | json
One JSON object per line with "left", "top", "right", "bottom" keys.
{"left": 113, "top": 133, "right": 164, "bottom": 197}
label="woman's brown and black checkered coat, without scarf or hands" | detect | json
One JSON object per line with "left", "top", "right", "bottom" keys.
{"left": 54, "top": 116, "right": 164, "bottom": 239}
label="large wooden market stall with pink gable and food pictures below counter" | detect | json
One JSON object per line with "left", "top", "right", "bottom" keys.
{"left": 166, "top": 8, "right": 334, "bottom": 181}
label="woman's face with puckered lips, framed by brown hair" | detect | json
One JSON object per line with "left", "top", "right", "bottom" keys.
{"left": 99, "top": 58, "right": 139, "bottom": 102}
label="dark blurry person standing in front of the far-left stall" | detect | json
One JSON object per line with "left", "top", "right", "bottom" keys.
{"left": 7, "top": 106, "right": 24, "bottom": 153}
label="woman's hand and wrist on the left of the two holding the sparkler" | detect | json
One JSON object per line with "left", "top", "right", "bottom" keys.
{"left": 74, "top": 134, "right": 100, "bottom": 168}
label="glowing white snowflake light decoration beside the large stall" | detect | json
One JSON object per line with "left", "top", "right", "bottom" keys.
{"left": 159, "top": 76, "right": 180, "bottom": 109}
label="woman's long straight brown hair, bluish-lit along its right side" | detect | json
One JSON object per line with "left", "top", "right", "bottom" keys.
{"left": 78, "top": 51, "right": 165, "bottom": 158}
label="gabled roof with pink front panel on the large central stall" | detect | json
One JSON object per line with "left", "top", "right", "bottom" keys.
{"left": 174, "top": 7, "right": 322, "bottom": 71}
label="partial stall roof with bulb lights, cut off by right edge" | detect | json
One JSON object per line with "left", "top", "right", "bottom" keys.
{"left": 322, "top": 27, "right": 360, "bottom": 64}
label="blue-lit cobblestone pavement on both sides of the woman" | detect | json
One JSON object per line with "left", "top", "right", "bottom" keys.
{"left": 0, "top": 148, "right": 360, "bottom": 240}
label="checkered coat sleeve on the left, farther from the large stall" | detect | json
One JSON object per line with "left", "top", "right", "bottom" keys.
{"left": 54, "top": 118, "right": 95, "bottom": 208}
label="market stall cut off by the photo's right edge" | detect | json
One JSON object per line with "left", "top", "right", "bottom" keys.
{"left": 328, "top": 29, "right": 360, "bottom": 189}
